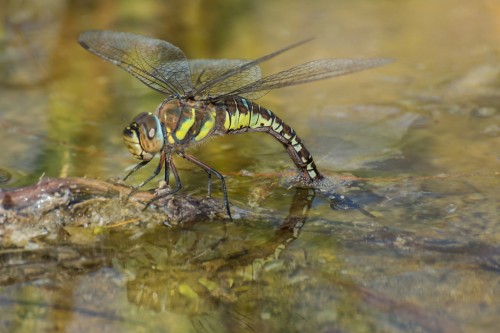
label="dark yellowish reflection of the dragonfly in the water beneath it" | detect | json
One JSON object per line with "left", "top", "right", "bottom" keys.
{"left": 122, "top": 189, "right": 314, "bottom": 314}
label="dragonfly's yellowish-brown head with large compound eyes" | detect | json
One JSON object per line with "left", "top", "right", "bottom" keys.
{"left": 123, "top": 112, "right": 164, "bottom": 161}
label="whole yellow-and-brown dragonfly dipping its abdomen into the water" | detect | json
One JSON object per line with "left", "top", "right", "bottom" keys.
{"left": 78, "top": 30, "right": 392, "bottom": 219}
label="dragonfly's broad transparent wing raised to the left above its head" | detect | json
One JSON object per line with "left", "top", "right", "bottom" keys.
{"left": 78, "top": 30, "right": 193, "bottom": 96}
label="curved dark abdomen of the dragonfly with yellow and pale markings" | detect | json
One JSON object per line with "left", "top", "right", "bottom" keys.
{"left": 223, "top": 97, "right": 323, "bottom": 182}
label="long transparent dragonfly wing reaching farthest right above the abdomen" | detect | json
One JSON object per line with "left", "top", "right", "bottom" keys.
{"left": 227, "top": 58, "right": 393, "bottom": 95}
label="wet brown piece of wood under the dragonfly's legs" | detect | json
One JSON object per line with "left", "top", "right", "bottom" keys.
{"left": 0, "top": 178, "right": 226, "bottom": 245}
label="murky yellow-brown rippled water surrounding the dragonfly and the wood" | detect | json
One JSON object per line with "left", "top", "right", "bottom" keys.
{"left": 0, "top": 0, "right": 500, "bottom": 332}
